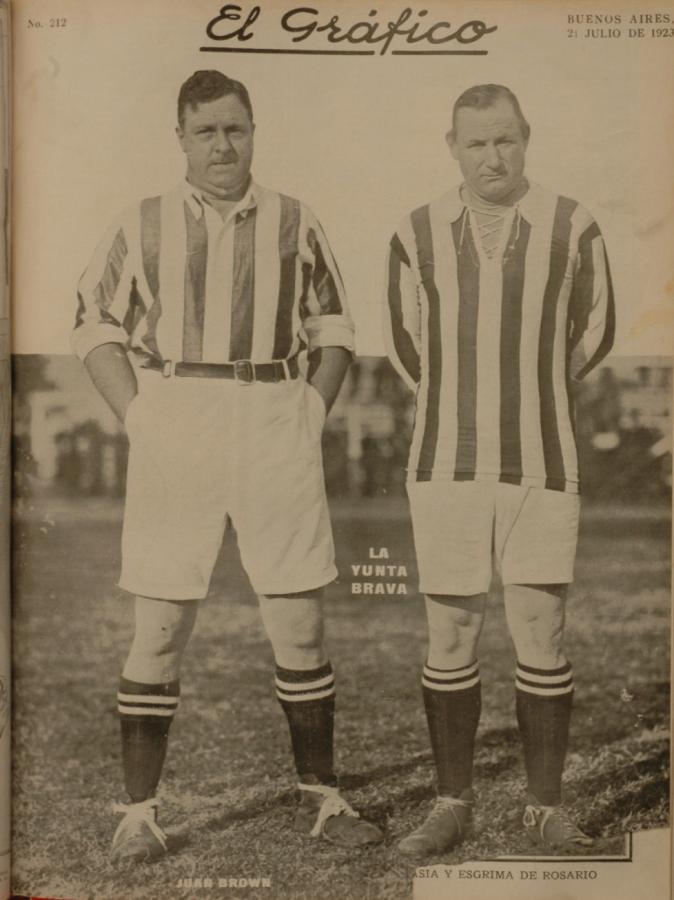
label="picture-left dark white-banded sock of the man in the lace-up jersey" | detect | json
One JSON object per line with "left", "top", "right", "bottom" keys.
{"left": 421, "top": 660, "right": 481, "bottom": 797}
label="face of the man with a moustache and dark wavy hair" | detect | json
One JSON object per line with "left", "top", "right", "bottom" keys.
{"left": 176, "top": 94, "right": 255, "bottom": 199}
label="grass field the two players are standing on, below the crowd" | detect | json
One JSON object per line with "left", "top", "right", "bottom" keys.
{"left": 13, "top": 501, "right": 670, "bottom": 900}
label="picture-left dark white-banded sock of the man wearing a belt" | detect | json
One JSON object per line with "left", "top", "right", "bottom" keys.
{"left": 117, "top": 678, "right": 180, "bottom": 803}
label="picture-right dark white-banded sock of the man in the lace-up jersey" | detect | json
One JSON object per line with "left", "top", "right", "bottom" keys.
{"left": 515, "top": 662, "right": 573, "bottom": 806}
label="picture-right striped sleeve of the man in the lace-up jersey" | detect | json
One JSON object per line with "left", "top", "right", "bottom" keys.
{"left": 569, "top": 221, "right": 615, "bottom": 381}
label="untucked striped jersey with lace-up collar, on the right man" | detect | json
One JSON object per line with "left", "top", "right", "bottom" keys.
{"left": 385, "top": 184, "right": 615, "bottom": 493}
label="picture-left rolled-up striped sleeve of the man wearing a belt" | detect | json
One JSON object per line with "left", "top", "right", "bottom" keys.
{"left": 71, "top": 211, "right": 135, "bottom": 360}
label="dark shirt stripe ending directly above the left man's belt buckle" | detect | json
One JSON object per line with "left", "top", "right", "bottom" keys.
{"left": 229, "top": 209, "right": 257, "bottom": 360}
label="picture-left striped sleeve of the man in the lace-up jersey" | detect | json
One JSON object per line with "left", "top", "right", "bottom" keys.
{"left": 383, "top": 233, "right": 421, "bottom": 390}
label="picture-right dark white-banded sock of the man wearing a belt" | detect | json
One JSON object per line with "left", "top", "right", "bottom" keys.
{"left": 276, "top": 662, "right": 337, "bottom": 785}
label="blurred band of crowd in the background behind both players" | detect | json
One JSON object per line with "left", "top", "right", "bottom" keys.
{"left": 13, "top": 356, "right": 672, "bottom": 505}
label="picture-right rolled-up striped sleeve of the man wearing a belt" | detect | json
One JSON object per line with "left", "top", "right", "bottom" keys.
{"left": 299, "top": 207, "right": 355, "bottom": 353}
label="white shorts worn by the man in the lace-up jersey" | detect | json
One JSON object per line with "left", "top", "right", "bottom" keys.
{"left": 407, "top": 481, "right": 580, "bottom": 596}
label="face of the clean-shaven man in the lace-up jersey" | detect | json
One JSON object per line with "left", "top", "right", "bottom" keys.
{"left": 447, "top": 98, "right": 527, "bottom": 203}
